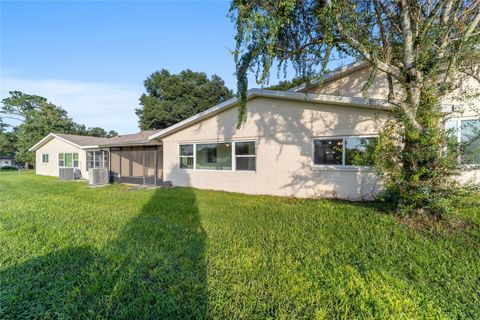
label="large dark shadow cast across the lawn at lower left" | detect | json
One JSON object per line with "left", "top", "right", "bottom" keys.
{"left": 0, "top": 189, "right": 208, "bottom": 319}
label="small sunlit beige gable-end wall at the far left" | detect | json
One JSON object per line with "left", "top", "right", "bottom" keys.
{"left": 35, "top": 138, "right": 87, "bottom": 178}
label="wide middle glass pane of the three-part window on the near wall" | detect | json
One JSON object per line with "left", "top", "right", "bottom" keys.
{"left": 197, "top": 143, "right": 232, "bottom": 170}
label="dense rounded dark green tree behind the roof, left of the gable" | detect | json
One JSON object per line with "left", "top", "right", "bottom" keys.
{"left": 135, "top": 69, "right": 233, "bottom": 130}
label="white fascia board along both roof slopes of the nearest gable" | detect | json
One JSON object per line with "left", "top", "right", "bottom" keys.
{"left": 148, "top": 89, "right": 392, "bottom": 140}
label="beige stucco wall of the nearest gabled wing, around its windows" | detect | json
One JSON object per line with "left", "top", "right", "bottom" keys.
{"left": 163, "top": 98, "right": 387, "bottom": 199}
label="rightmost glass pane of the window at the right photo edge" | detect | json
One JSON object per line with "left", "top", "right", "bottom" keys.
{"left": 460, "top": 120, "right": 480, "bottom": 164}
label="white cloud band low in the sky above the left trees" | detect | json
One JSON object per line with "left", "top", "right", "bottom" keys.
{"left": 0, "top": 77, "right": 143, "bottom": 134}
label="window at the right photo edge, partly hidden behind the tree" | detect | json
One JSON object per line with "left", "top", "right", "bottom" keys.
{"left": 445, "top": 119, "right": 480, "bottom": 165}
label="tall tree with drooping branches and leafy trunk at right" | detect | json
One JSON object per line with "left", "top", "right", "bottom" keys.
{"left": 230, "top": 0, "right": 480, "bottom": 213}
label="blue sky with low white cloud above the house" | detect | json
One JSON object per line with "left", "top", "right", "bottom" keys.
{"left": 0, "top": 0, "right": 344, "bottom": 134}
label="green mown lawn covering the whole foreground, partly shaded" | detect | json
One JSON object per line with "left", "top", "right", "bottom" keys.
{"left": 0, "top": 173, "right": 480, "bottom": 319}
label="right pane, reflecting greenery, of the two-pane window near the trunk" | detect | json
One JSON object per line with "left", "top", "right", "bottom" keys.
{"left": 345, "top": 138, "right": 377, "bottom": 166}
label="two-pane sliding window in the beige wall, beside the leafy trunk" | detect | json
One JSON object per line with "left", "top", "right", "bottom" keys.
{"left": 313, "top": 137, "right": 377, "bottom": 166}
